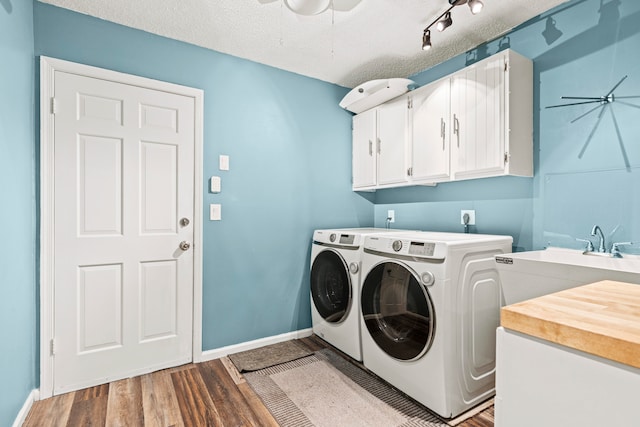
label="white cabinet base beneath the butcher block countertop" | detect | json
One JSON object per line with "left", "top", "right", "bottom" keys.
{"left": 495, "top": 327, "right": 640, "bottom": 427}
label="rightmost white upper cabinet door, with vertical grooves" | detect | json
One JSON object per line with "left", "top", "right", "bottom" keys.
{"left": 451, "top": 55, "right": 505, "bottom": 179}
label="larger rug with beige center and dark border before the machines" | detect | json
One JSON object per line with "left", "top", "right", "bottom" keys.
{"left": 244, "top": 349, "right": 448, "bottom": 427}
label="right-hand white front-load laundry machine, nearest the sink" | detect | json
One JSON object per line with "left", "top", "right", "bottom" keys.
{"left": 361, "top": 232, "right": 513, "bottom": 418}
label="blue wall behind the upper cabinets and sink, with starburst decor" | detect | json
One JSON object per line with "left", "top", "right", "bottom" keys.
{"left": 375, "top": 0, "right": 640, "bottom": 254}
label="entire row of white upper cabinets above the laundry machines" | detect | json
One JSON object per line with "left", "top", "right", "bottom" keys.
{"left": 353, "top": 50, "right": 533, "bottom": 190}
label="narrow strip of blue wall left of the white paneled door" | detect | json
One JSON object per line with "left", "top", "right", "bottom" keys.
{"left": 0, "top": 0, "right": 37, "bottom": 426}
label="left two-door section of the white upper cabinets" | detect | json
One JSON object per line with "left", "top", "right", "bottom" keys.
{"left": 352, "top": 96, "right": 408, "bottom": 190}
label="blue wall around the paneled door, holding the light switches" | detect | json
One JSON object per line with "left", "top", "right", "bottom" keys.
{"left": 34, "top": 2, "right": 373, "bottom": 350}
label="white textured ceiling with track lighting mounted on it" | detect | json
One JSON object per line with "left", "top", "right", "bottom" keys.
{"left": 40, "top": 0, "right": 566, "bottom": 88}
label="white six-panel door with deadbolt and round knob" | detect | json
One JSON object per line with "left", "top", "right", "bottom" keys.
{"left": 52, "top": 71, "right": 195, "bottom": 394}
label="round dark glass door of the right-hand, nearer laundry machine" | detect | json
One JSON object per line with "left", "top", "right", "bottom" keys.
{"left": 361, "top": 261, "right": 435, "bottom": 360}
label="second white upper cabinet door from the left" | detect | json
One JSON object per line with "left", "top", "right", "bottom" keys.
{"left": 377, "top": 100, "right": 408, "bottom": 185}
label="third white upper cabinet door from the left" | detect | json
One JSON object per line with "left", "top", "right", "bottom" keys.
{"left": 410, "top": 79, "right": 451, "bottom": 182}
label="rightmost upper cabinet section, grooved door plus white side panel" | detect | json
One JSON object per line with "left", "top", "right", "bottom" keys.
{"left": 451, "top": 50, "right": 533, "bottom": 180}
